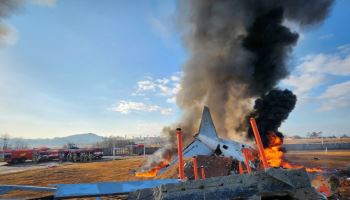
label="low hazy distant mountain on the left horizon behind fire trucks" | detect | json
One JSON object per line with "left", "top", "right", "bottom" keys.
{"left": 10, "top": 133, "right": 104, "bottom": 148}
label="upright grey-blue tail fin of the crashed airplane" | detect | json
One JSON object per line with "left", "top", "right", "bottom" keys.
{"left": 198, "top": 106, "right": 218, "bottom": 138}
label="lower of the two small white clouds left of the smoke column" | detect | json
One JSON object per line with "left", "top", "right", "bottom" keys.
{"left": 111, "top": 101, "right": 172, "bottom": 115}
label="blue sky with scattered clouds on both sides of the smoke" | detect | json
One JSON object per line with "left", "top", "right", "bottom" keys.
{"left": 0, "top": 0, "right": 350, "bottom": 138}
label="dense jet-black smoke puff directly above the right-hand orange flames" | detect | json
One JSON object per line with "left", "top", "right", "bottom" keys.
{"left": 247, "top": 89, "right": 297, "bottom": 147}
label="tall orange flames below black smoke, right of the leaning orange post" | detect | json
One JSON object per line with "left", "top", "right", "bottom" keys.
{"left": 264, "top": 132, "right": 322, "bottom": 172}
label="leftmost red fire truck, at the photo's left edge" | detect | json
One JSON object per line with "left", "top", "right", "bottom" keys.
{"left": 0, "top": 149, "right": 33, "bottom": 164}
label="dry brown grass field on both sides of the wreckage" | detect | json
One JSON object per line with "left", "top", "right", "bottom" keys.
{"left": 0, "top": 151, "right": 350, "bottom": 199}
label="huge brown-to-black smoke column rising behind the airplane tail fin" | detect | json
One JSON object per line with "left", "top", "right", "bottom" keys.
{"left": 164, "top": 0, "right": 333, "bottom": 150}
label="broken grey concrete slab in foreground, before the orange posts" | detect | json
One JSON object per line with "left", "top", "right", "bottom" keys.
{"left": 128, "top": 168, "right": 322, "bottom": 200}
